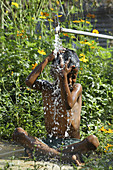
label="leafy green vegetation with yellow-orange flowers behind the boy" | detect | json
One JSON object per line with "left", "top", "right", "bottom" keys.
{"left": 0, "top": 0, "right": 113, "bottom": 169}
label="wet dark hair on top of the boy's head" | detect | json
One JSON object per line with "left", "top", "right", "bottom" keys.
{"left": 52, "top": 49, "right": 80, "bottom": 69}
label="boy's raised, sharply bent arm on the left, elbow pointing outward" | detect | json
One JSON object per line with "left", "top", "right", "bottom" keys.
{"left": 25, "top": 53, "right": 55, "bottom": 90}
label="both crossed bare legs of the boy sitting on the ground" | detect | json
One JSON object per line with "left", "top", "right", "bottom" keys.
{"left": 13, "top": 127, "right": 99, "bottom": 161}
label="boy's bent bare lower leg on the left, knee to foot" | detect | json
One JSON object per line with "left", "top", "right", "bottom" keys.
{"left": 13, "top": 127, "right": 60, "bottom": 158}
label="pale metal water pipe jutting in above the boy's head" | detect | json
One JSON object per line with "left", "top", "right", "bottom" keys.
{"left": 60, "top": 27, "right": 113, "bottom": 40}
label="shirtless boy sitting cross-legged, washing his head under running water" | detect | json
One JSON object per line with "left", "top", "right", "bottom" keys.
{"left": 13, "top": 49, "right": 99, "bottom": 164}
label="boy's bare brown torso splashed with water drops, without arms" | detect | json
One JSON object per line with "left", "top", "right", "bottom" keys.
{"left": 36, "top": 81, "right": 82, "bottom": 138}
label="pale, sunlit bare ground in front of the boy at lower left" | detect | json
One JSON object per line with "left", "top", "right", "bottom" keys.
{"left": 0, "top": 141, "right": 77, "bottom": 170}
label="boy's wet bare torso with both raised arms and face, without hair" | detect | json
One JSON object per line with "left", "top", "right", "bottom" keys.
{"left": 26, "top": 54, "right": 82, "bottom": 138}
